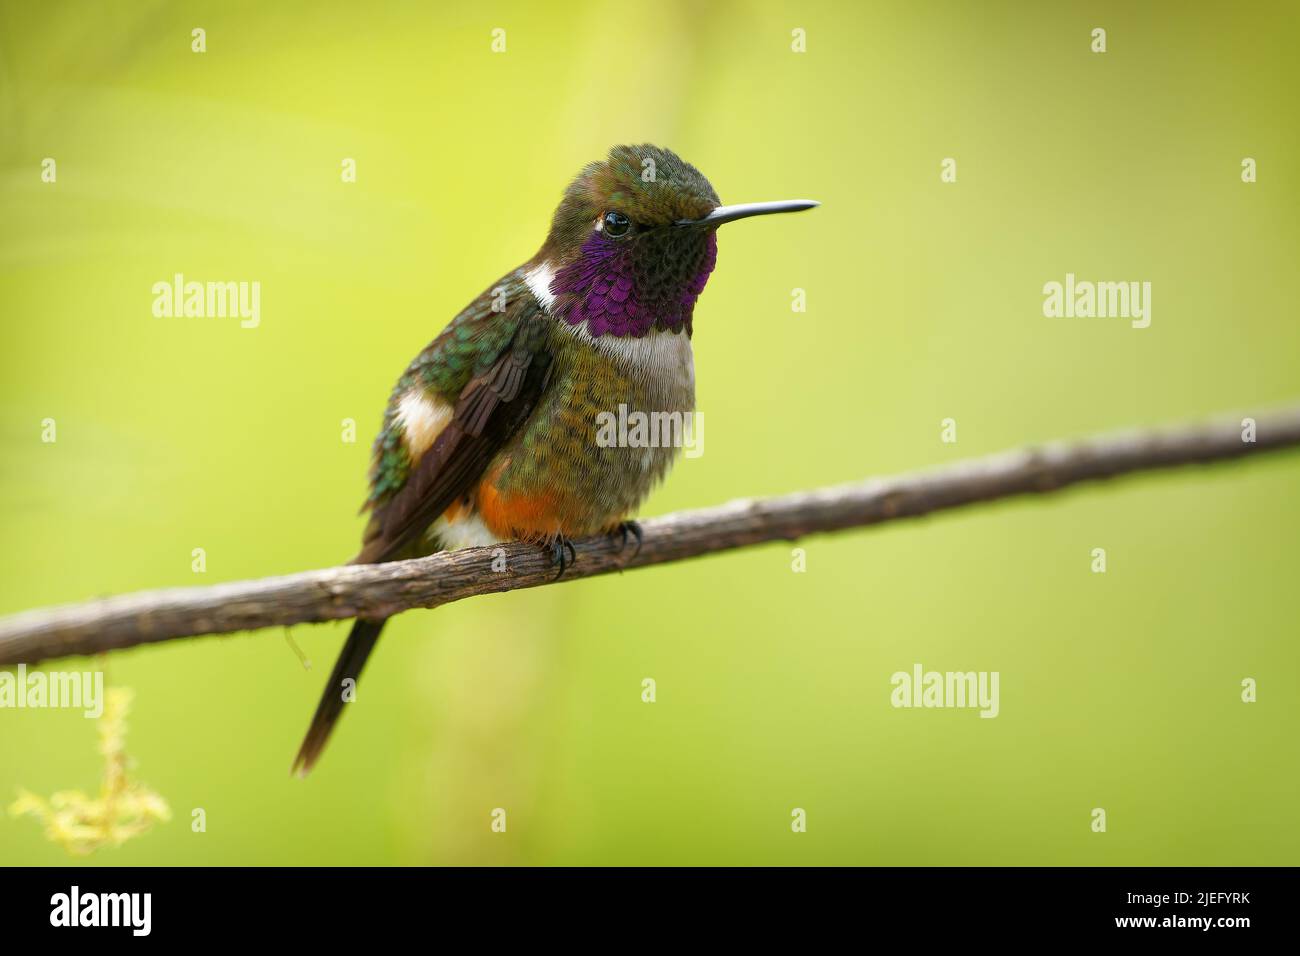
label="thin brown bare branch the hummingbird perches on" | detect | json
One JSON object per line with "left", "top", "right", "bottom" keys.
{"left": 0, "top": 406, "right": 1300, "bottom": 665}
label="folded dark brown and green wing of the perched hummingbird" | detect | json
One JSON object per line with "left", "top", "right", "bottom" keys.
{"left": 354, "top": 272, "right": 551, "bottom": 563}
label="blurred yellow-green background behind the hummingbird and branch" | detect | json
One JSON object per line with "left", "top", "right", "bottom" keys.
{"left": 0, "top": 1, "right": 1300, "bottom": 864}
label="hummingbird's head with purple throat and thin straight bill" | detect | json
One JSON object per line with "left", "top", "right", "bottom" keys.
{"left": 527, "top": 144, "right": 816, "bottom": 337}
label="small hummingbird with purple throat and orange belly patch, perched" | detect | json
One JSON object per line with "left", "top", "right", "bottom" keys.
{"left": 294, "top": 144, "right": 818, "bottom": 775}
